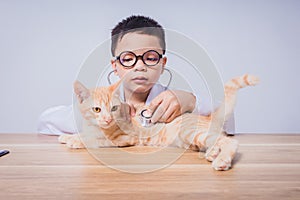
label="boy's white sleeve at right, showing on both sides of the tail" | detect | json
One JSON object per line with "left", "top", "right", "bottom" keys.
{"left": 193, "top": 95, "right": 235, "bottom": 134}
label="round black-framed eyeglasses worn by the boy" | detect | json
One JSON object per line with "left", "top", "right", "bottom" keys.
{"left": 116, "top": 50, "right": 162, "bottom": 68}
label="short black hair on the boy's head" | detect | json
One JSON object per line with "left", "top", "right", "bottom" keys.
{"left": 111, "top": 15, "right": 166, "bottom": 56}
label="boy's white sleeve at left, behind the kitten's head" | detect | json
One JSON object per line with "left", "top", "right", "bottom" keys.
{"left": 37, "top": 105, "right": 80, "bottom": 135}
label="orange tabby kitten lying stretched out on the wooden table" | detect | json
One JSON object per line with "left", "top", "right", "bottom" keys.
{"left": 59, "top": 75, "right": 258, "bottom": 170}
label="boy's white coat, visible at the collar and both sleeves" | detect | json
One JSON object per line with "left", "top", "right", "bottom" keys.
{"left": 37, "top": 84, "right": 235, "bottom": 135}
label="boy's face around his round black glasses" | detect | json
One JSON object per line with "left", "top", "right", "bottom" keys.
{"left": 111, "top": 32, "right": 167, "bottom": 93}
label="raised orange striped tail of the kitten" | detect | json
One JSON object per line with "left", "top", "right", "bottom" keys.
{"left": 211, "top": 74, "right": 259, "bottom": 130}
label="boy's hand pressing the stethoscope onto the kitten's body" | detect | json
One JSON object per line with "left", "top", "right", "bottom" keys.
{"left": 149, "top": 90, "right": 196, "bottom": 123}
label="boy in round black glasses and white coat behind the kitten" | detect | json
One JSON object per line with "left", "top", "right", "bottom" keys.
{"left": 38, "top": 16, "right": 233, "bottom": 134}
